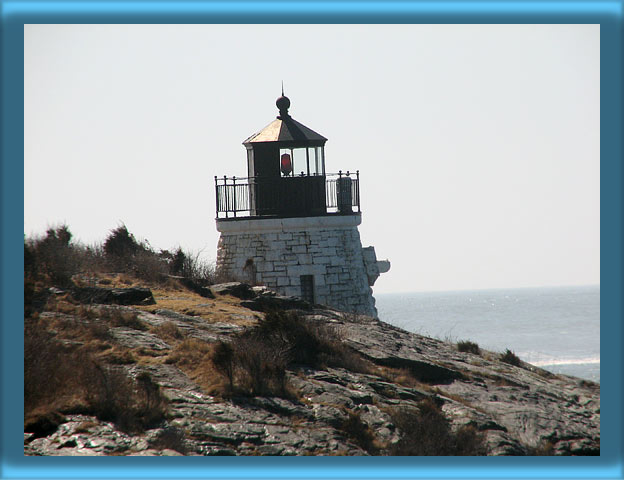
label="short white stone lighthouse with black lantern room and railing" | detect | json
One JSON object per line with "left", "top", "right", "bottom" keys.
{"left": 215, "top": 93, "right": 390, "bottom": 316}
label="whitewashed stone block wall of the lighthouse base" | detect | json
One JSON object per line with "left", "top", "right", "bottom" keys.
{"left": 217, "top": 215, "right": 377, "bottom": 317}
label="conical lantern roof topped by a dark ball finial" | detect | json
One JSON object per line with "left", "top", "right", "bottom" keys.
{"left": 243, "top": 96, "right": 327, "bottom": 146}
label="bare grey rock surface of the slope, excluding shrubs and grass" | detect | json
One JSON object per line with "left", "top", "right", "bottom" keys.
{"left": 24, "top": 284, "right": 600, "bottom": 455}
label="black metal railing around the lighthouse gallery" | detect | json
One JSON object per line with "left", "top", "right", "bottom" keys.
{"left": 215, "top": 171, "right": 360, "bottom": 218}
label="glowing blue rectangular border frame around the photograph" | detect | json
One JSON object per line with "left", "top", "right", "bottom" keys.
{"left": 0, "top": 0, "right": 624, "bottom": 479}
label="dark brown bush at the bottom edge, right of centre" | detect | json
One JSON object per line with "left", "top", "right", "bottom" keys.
{"left": 390, "top": 399, "right": 487, "bottom": 456}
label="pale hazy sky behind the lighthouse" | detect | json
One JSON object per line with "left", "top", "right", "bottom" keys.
{"left": 24, "top": 25, "right": 600, "bottom": 293}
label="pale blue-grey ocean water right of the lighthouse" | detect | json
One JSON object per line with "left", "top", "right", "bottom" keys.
{"left": 375, "top": 285, "right": 600, "bottom": 382}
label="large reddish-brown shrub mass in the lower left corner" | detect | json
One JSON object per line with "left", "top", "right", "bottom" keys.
{"left": 24, "top": 319, "right": 167, "bottom": 433}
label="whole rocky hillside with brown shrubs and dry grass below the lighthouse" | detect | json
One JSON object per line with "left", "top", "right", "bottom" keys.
{"left": 24, "top": 226, "right": 600, "bottom": 455}
